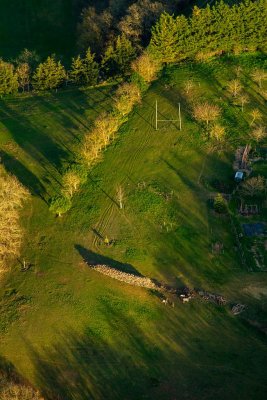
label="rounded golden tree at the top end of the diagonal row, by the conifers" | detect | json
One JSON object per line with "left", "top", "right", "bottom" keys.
{"left": 132, "top": 53, "right": 161, "bottom": 83}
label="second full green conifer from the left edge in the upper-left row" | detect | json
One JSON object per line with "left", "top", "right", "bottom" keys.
{"left": 33, "top": 56, "right": 66, "bottom": 90}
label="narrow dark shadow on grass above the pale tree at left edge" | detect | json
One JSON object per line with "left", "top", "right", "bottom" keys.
{"left": 0, "top": 150, "right": 46, "bottom": 200}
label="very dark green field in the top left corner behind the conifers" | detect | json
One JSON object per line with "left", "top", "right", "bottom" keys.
{"left": 0, "top": 0, "right": 80, "bottom": 58}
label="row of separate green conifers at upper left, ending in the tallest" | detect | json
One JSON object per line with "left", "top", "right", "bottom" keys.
{"left": 0, "top": 35, "right": 136, "bottom": 95}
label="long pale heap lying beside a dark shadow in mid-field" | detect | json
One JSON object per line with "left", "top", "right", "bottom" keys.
{"left": 90, "top": 265, "right": 158, "bottom": 289}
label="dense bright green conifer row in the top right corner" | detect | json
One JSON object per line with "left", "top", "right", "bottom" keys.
{"left": 149, "top": 0, "right": 267, "bottom": 63}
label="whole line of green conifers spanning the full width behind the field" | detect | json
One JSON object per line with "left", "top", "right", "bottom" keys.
{"left": 0, "top": 0, "right": 267, "bottom": 96}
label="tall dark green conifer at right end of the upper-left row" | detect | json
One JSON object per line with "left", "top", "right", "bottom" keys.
{"left": 102, "top": 34, "right": 136, "bottom": 76}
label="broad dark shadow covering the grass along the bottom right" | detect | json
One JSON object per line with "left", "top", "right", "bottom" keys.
{"left": 27, "top": 298, "right": 266, "bottom": 400}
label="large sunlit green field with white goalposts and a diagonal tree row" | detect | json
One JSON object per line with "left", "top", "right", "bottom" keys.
{"left": 0, "top": 56, "right": 267, "bottom": 400}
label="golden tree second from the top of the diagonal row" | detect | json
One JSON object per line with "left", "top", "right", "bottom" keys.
{"left": 115, "top": 82, "right": 141, "bottom": 115}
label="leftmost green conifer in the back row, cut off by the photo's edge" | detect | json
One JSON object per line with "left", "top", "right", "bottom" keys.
{"left": 0, "top": 58, "right": 19, "bottom": 96}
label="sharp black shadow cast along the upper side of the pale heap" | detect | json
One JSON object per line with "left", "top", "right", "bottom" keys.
{"left": 74, "top": 244, "right": 142, "bottom": 276}
